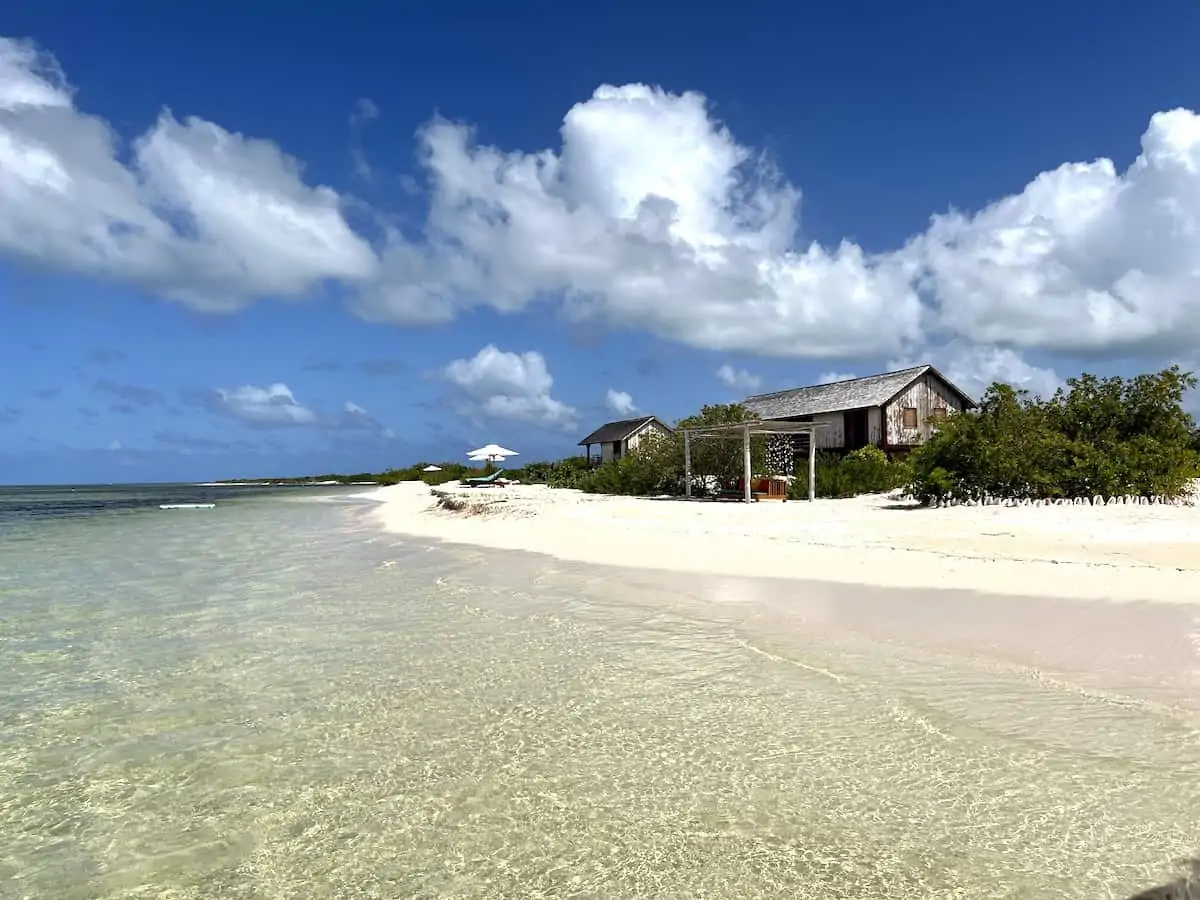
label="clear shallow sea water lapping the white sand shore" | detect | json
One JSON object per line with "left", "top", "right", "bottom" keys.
{"left": 0, "top": 486, "right": 1200, "bottom": 900}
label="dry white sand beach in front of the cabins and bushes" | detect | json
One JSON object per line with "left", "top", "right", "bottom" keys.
{"left": 364, "top": 482, "right": 1200, "bottom": 604}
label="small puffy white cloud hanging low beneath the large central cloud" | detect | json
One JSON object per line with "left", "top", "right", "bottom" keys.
{"left": 443, "top": 344, "right": 576, "bottom": 427}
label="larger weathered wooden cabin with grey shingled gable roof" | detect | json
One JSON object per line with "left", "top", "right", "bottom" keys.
{"left": 742, "top": 366, "right": 976, "bottom": 452}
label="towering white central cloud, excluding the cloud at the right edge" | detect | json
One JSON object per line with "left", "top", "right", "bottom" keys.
{"left": 384, "top": 84, "right": 920, "bottom": 356}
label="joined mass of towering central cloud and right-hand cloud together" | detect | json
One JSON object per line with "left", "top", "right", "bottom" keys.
{"left": 384, "top": 84, "right": 1200, "bottom": 358}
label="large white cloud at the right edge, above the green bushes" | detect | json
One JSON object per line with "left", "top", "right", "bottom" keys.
{"left": 916, "top": 109, "right": 1200, "bottom": 353}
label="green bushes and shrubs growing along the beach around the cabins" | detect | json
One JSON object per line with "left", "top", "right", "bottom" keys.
{"left": 246, "top": 366, "right": 1200, "bottom": 503}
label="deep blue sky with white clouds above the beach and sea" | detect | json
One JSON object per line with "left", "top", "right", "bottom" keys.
{"left": 0, "top": 0, "right": 1200, "bottom": 484}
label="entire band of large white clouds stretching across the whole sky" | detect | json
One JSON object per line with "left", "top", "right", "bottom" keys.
{"left": 7, "top": 40, "right": 1200, "bottom": 367}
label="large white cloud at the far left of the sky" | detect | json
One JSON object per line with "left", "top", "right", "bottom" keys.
{"left": 0, "top": 38, "right": 377, "bottom": 311}
